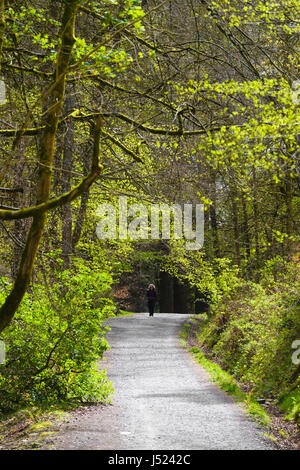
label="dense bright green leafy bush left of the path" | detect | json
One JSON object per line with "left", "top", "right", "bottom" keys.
{"left": 0, "top": 263, "right": 115, "bottom": 411}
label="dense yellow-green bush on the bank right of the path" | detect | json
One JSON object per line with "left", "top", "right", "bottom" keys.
{"left": 199, "top": 258, "right": 300, "bottom": 424}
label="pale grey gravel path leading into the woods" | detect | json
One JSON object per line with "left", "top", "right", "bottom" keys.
{"left": 48, "top": 313, "right": 274, "bottom": 450}
